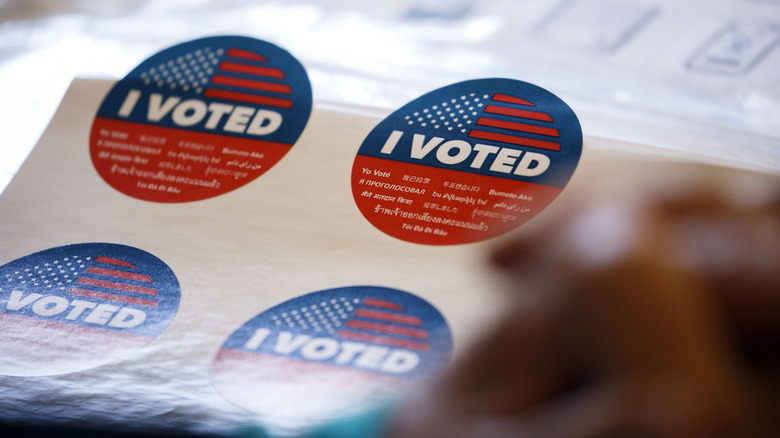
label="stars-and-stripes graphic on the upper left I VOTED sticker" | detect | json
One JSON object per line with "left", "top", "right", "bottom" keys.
{"left": 141, "top": 47, "right": 292, "bottom": 108}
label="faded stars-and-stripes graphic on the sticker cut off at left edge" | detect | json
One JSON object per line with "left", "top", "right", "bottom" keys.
{"left": 5, "top": 255, "right": 158, "bottom": 307}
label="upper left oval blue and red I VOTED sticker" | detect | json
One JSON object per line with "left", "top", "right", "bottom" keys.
{"left": 90, "top": 36, "right": 312, "bottom": 203}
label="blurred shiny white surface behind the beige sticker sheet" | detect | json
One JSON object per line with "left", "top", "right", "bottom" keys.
{"left": 0, "top": 0, "right": 780, "bottom": 191}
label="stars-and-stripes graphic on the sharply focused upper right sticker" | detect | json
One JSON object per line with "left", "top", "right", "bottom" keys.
{"left": 404, "top": 93, "right": 561, "bottom": 151}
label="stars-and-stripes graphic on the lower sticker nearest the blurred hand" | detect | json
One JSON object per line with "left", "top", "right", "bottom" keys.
{"left": 271, "top": 297, "right": 430, "bottom": 351}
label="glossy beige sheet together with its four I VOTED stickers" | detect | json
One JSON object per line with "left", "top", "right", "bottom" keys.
{"left": 0, "top": 36, "right": 582, "bottom": 428}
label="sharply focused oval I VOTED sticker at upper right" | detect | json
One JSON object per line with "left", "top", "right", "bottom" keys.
{"left": 352, "top": 79, "right": 582, "bottom": 245}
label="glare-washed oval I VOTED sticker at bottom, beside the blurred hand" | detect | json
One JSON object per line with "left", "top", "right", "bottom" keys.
{"left": 212, "top": 286, "right": 452, "bottom": 425}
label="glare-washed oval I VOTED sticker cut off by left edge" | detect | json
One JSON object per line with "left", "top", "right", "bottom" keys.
{"left": 0, "top": 243, "right": 180, "bottom": 376}
